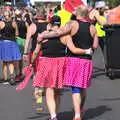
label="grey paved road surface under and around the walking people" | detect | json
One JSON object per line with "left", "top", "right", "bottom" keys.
{"left": 0, "top": 49, "right": 120, "bottom": 120}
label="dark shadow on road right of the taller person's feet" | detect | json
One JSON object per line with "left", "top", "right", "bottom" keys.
{"left": 84, "top": 105, "right": 112, "bottom": 120}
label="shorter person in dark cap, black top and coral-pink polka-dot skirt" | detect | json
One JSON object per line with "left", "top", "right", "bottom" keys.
{"left": 32, "top": 16, "right": 92, "bottom": 120}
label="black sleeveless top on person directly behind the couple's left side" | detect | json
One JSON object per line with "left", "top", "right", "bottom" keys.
{"left": 31, "top": 22, "right": 48, "bottom": 52}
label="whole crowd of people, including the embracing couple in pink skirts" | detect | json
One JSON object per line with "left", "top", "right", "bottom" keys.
{"left": 0, "top": 1, "right": 115, "bottom": 120}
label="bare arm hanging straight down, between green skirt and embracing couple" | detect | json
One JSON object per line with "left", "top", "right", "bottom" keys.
{"left": 24, "top": 23, "right": 36, "bottom": 53}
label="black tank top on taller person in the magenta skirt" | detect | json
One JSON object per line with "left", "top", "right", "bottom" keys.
{"left": 67, "top": 20, "right": 93, "bottom": 59}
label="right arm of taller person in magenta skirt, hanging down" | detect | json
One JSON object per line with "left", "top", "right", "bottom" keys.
{"left": 90, "top": 25, "right": 99, "bottom": 49}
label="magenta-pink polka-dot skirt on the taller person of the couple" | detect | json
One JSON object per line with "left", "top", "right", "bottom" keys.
{"left": 63, "top": 57, "right": 93, "bottom": 88}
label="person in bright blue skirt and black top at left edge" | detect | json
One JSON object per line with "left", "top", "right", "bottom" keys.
{"left": 0, "top": 11, "right": 21, "bottom": 85}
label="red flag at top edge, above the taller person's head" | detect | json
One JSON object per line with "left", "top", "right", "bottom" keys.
{"left": 64, "top": 0, "right": 86, "bottom": 13}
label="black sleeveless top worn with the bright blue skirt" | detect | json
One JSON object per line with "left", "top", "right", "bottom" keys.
{"left": 0, "top": 21, "right": 15, "bottom": 41}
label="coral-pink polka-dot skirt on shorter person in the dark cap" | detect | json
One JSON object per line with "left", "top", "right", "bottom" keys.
{"left": 33, "top": 57, "right": 65, "bottom": 88}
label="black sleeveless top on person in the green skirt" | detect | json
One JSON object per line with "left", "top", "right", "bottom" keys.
{"left": 16, "top": 20, "right": 27, "bottom": 39}
